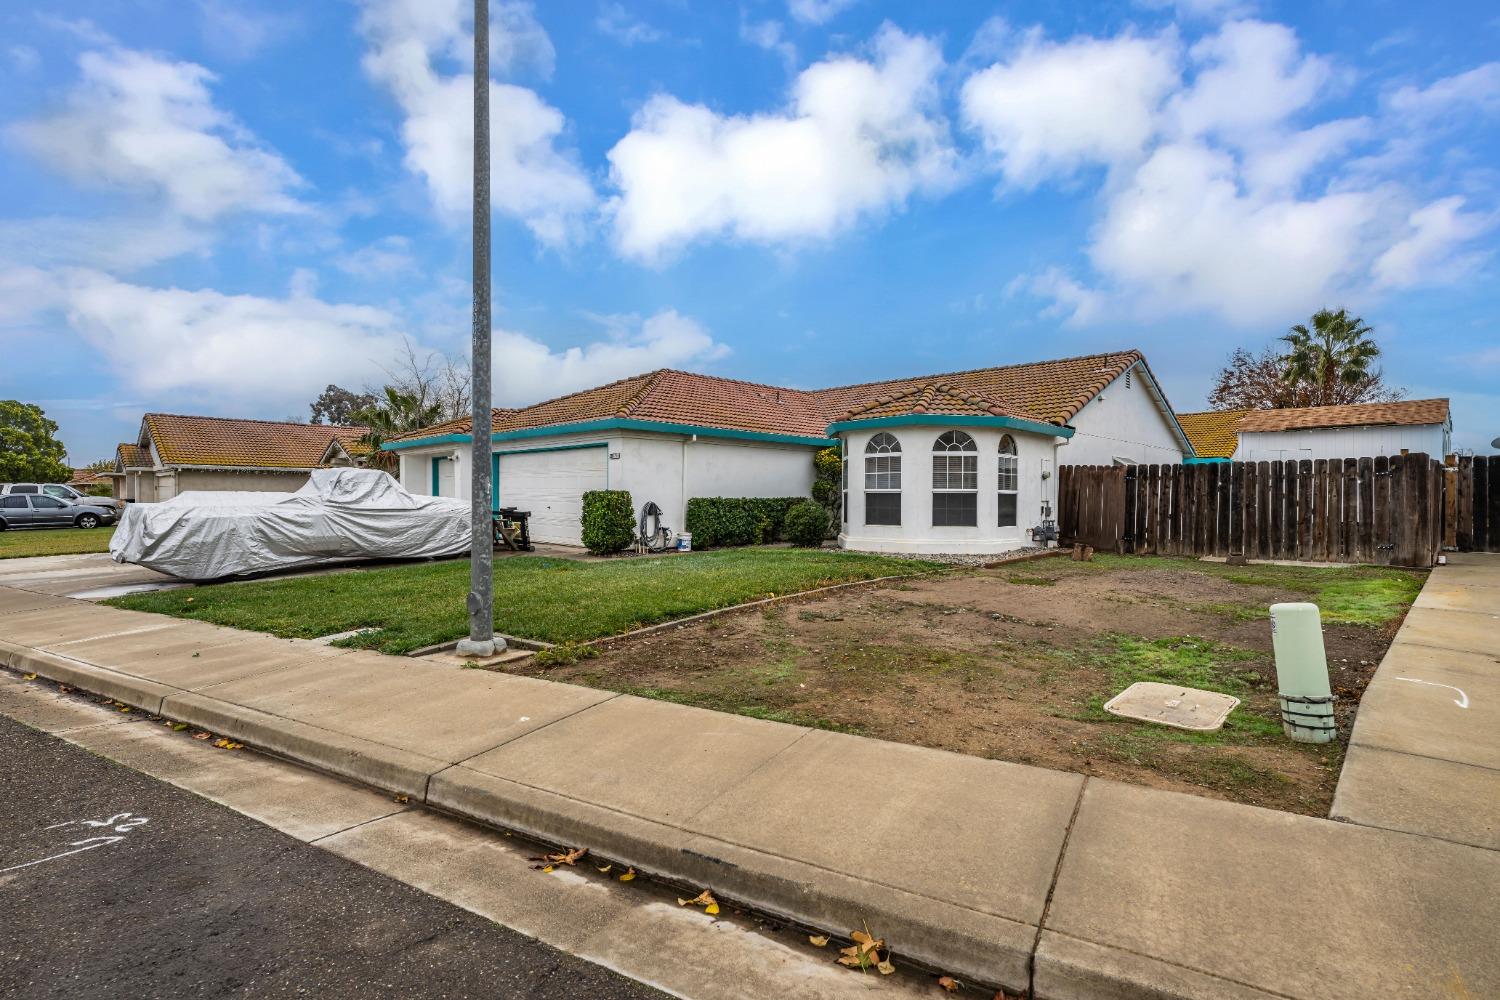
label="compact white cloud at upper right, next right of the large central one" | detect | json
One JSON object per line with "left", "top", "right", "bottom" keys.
{"left": 962, "top": 31, "right": 1179, "bottom": 186}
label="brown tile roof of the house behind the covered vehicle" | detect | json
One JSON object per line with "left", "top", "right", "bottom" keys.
{"left": 143, "top": 414, "right": 365, "bottom": 469}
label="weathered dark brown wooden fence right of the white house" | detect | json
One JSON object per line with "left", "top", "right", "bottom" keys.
{"left": 1058, "top": 454, "right": 1446, "bottom": 567}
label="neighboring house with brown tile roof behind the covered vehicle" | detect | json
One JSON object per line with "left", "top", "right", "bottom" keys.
{"left": 111, "top": 414, "right": 369, "bottom": 502}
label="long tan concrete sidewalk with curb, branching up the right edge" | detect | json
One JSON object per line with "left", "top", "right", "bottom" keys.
{"left": 0, "top": 556, "right": 1500, "bottom": 1000}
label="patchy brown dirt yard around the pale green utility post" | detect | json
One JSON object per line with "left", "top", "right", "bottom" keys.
{"left": 522, "top": 556, "right": 1422, "bottom": 816}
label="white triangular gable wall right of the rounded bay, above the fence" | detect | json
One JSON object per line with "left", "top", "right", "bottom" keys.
{"left": 1058, "top": 364, "right": 1184, "bottom": 465}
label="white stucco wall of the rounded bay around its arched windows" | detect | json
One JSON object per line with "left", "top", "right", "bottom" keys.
{"left": 839, "top": 424, "right": 1058, "bottom": 555}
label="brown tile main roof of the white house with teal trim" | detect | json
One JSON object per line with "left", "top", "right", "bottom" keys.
{"left": 392, "top": 351, "right": 1145, "bottom": 441}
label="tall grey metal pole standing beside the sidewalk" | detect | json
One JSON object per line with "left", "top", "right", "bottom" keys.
{"left": 458, "top": 0, "right": 506, "bottom": 657}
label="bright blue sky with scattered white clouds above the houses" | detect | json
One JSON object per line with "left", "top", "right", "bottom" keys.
{"left": 0, "top": 0, "right": 1500, "bottom": 463}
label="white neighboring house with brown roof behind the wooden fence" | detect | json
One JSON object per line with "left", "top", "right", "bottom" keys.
{"left": 1235, "top": 399, "right": 1454, "bottom": 462}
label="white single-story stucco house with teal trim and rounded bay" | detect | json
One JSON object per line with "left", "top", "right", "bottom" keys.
{"left": 384, "top": 351, "right": 1193, "bottom": 553}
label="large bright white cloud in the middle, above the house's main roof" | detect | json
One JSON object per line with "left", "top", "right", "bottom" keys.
{"left": 609, "top": 25, "right": 957, "bottom": 261}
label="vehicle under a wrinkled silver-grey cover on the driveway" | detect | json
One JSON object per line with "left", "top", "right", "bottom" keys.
{"left": 110, "top": 469, "right": 470, "bottom": 580}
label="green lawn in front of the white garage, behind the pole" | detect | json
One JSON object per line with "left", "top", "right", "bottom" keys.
{"left": 107, "top": 549, "right": 938, "bottom": 654}
